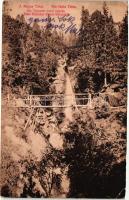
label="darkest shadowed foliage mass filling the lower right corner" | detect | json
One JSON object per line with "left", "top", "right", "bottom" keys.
{"left": 65, "top": 111, "right": 125, "bottom": 198}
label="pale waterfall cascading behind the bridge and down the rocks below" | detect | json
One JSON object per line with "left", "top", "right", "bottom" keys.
{"left": 49, "top": 55, "right": 76, "bottom": 197}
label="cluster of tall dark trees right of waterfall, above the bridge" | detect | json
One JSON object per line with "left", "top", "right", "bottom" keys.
{"left": 72, "top": 3, "right": 128, "bottom": 92}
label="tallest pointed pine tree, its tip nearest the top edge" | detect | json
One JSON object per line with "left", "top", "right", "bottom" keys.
{"left": 91, "top": 3, "right": 118, "bottom": 76}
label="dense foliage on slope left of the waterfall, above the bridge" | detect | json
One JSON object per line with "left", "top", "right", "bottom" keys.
{"left": 2, "top": 15, "right": 64, "bottom": 94}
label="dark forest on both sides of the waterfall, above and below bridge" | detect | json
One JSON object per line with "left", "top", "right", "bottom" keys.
{"left": 1, "top": 3, "right": 128, "bottom": 198}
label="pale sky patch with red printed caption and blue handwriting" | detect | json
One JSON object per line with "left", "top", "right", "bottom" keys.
{"left": 20, "top": 3, "right": 79, "bottom": 35}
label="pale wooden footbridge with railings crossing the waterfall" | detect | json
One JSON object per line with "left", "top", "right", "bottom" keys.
{"left": 7, "top": 93, "right": 91, "bottom": 108}
